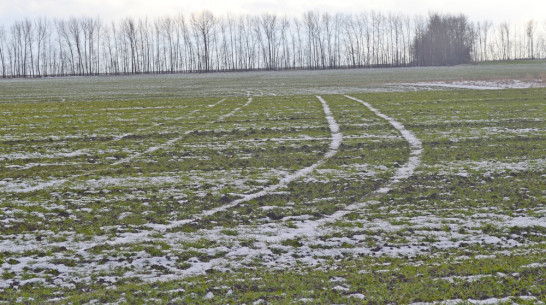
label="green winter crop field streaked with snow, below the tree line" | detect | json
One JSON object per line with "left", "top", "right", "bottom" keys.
{"left": 0, "top": 62, "right": 546, "bottom": 304}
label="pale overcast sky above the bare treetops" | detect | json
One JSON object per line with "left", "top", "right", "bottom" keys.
{"left": 0, "top": 0, "right": 546, "bottom": 26}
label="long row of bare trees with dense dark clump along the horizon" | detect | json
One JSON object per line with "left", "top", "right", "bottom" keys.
{"left": 0, "top": 11, "right": 546, "bottom": 78}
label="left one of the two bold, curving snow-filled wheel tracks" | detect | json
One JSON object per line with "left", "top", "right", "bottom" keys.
{"left": 154, "top": 96, "right": 343, "bottom": 231}
